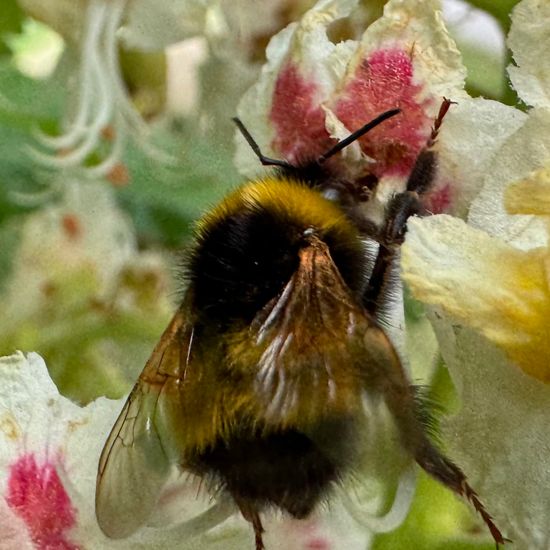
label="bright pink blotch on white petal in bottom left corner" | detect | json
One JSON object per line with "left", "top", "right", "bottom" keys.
{"left": 6, "top": 454, "right": 79, "bottom": 550}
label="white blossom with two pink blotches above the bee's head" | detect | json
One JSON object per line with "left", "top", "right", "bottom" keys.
{"left": 236, "top": 0, "right": 467, "bottom": 219}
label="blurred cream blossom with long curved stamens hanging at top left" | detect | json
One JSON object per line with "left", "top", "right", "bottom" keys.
{"left": 20, "top": 0, "right": 316, "bottom": 182}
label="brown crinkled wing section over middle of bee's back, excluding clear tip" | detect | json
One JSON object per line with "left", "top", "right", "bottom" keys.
{"left": 248, "top": 238, "right": 370, "bottom": 426}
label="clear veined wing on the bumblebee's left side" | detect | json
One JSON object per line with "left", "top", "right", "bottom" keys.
{"left": 96, "top": 310, "right": 193, "bottom": 538}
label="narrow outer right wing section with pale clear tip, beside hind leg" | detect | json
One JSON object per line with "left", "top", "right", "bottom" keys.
{"left": 336, "top": 326, "right": 425, "bottom": 533}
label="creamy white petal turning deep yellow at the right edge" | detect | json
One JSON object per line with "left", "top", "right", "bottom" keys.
{"left": 402, "top": 216, "right": 550, "bottom": 384}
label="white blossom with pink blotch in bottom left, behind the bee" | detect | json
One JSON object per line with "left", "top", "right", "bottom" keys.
{"left": 0, "top": 352, "right": 371, "bottom": 550}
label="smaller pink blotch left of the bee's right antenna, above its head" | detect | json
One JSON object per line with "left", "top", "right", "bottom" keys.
{"left": 269, "top": 63, "right": 334, "bottom": 164}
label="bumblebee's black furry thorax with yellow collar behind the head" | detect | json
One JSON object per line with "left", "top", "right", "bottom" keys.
{"left": 187, "top": 178, "right": 365, "bottom": 323}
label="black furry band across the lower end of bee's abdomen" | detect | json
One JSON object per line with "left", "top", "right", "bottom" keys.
{"left": 190, "top": 418, "right": 358, "bottom": 518}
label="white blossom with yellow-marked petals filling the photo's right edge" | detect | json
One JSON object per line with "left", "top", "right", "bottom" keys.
{"left": 402, "top": 0, "right": 550, "bottom": 550}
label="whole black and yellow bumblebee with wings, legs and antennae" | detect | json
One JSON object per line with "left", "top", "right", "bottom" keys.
{"left": 96, "top": 104, "right": 505, "bottom": 550}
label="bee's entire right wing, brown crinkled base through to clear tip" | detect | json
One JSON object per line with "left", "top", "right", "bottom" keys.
{"left": 252, "top": 239, "right": 423, "bottom": 532}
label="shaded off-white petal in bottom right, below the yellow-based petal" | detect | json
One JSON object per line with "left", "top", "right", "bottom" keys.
{"left": 434, "top": 326, "right": 550, "bottom": 550}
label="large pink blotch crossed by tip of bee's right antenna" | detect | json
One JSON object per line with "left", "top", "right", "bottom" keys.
{"left": 334, "top": 48, "right": 433, "bottom": 177}
